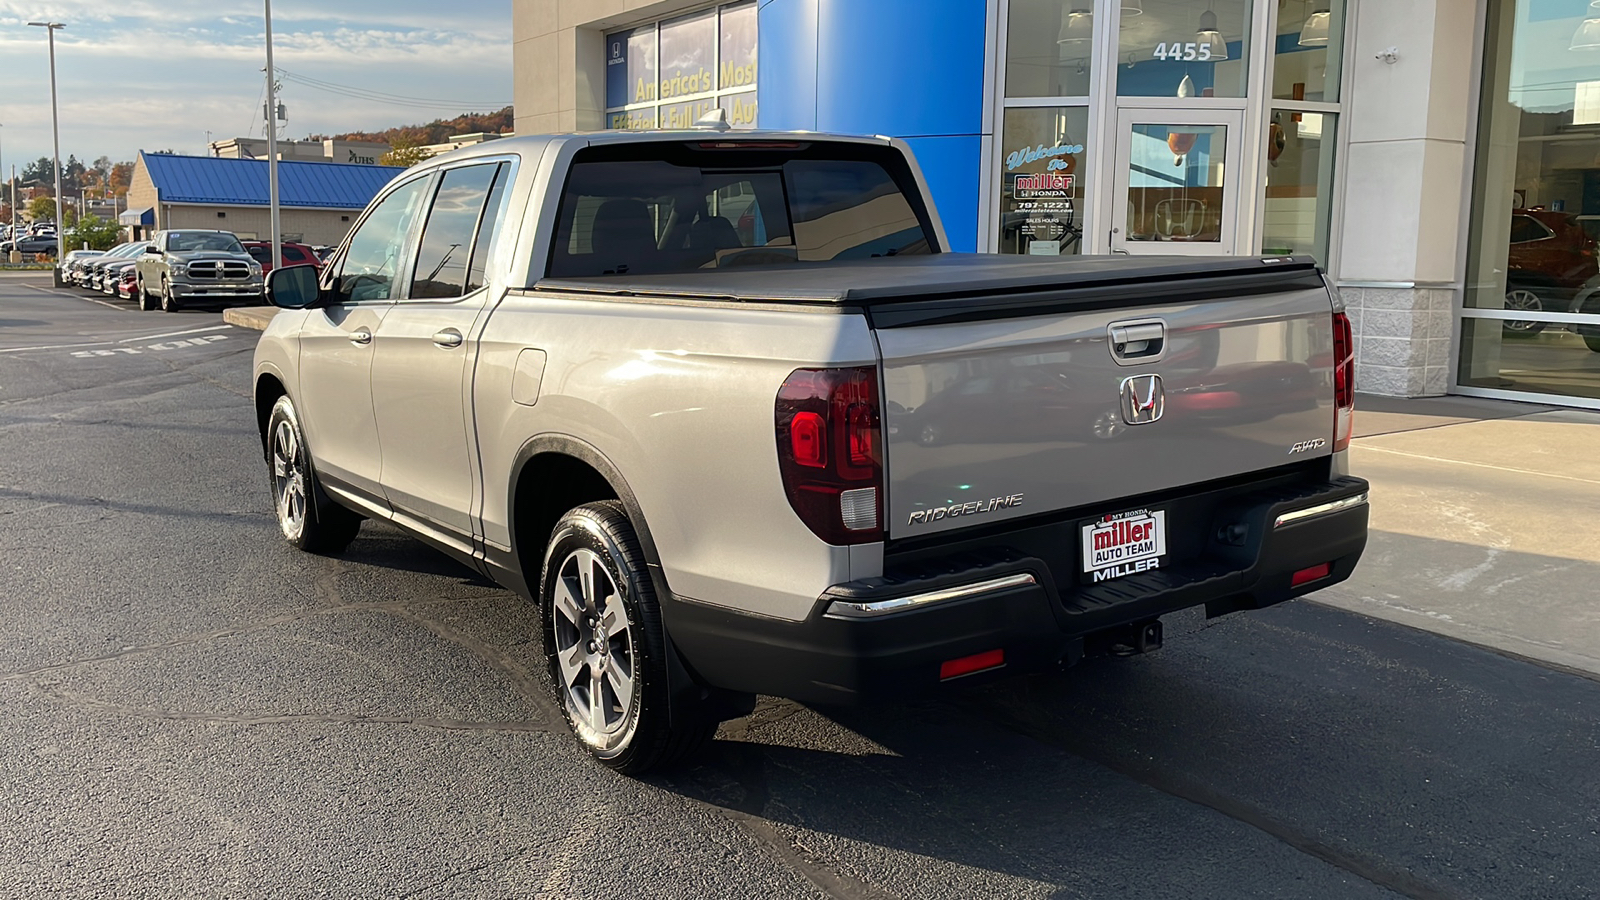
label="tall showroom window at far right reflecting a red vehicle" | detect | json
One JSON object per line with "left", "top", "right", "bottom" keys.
{"left": 1458, "top": 0, "right": 1600, "bottom": 405}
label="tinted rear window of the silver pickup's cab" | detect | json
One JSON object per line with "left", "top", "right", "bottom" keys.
{"left": 550, "top": 144, "right": 938, "bottom": 277}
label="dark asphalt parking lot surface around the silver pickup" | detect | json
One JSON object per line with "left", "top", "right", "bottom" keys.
{"left": 0, "top": 274, "right": 1600, "bottom": 900}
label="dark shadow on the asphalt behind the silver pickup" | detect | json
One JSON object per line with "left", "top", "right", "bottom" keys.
{"left": 649, "top": 602, "right": 1600, "bottom": 898}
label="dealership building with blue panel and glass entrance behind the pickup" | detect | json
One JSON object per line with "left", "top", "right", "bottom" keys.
{"left": 514, "top": 0, "right": 1600, "bottom": 408}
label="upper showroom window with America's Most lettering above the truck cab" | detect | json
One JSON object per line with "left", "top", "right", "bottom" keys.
{"left": 605, "top": 0, "right": 757, "bottom": 128}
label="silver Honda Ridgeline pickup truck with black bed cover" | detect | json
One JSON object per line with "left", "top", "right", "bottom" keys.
{"left": 254, "top": 131, "right": 1368, "bottom": 773}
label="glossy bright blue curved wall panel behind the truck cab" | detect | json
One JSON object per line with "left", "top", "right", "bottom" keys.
{"left": 757, "top": 0, "right": 987, "bottom": 250}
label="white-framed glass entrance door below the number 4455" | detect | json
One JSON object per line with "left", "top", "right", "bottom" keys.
{"left": 1110, "top": 109, "right": 1245, "bottom": 255}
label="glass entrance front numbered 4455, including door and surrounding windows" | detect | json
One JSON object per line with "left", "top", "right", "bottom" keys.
{"left": 986, "top": 0, "right": 1344, "bottom": 259}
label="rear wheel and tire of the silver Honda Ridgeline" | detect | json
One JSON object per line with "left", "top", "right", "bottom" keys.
{"left": 539, "top": 501, "right": 717, "bottom": 775}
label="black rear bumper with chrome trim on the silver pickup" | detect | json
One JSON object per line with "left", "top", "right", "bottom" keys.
{"left": 666, "top": 477, "right": 1368, "bottom": 703}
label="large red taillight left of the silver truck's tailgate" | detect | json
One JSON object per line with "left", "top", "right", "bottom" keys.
{"left": 776, "top": 365, "right": 883, "bottom": 544}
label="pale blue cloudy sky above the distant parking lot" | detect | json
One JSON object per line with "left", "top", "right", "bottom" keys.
{"left": 0, "top": 0, "right": 512, "bottom": 176}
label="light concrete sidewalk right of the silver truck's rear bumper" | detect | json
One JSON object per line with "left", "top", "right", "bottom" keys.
{"left": 1312, "top": 396, "right": 1600, "bottom": 674}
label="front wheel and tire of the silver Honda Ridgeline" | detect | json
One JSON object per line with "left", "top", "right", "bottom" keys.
{"left": 267, "top": 397, "right": 362, "bottom": 556}
